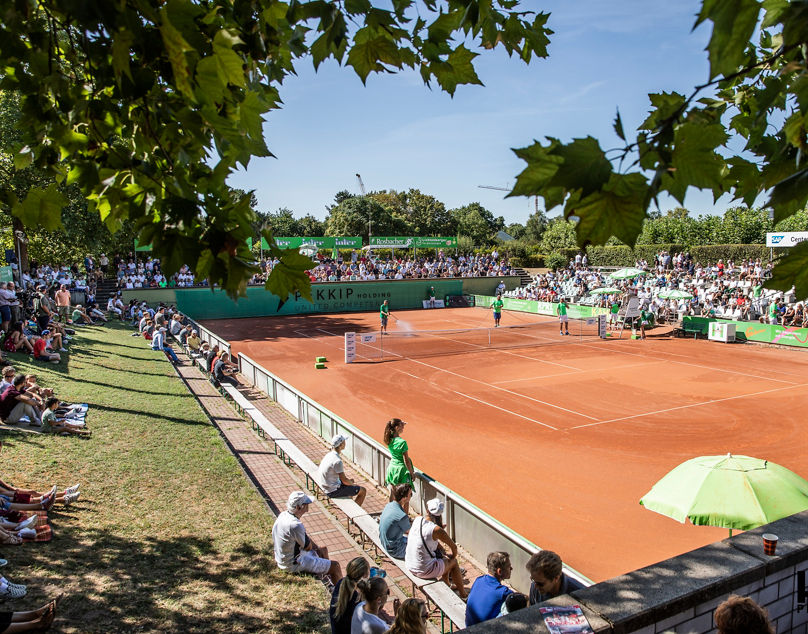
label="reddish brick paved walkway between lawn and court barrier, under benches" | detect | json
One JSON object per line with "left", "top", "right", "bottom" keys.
{"left": 176, "top": 353, "right": 482, "bottom": 628}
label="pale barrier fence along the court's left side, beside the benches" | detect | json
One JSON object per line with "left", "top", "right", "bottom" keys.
{"left": 239, "top": 354, "right": 592, "bottom": 593}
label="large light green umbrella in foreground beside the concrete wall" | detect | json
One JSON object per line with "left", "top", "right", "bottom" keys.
{"left": 640, "top": 454, "right": 808, "bottom": 535}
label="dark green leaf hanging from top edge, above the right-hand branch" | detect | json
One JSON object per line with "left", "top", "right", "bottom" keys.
{"left": 694, "top": 0, "right": 760, "bottom": 79}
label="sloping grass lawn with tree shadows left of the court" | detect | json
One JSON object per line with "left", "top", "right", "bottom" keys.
{"left": 0, "top": 324, "right": 329, "bottom": 632}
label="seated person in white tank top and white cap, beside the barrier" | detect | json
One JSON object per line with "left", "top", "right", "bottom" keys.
{"left": 404, "top": 498, "right": 467, "bottom": 599}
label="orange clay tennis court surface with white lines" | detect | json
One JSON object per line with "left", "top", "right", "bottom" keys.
{"left": 204, "top": 308, "right": 808, "bottom": 581}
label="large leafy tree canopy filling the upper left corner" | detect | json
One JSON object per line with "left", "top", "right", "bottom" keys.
{"left": 0, "top": 0, "right": 549, "bottom": 298}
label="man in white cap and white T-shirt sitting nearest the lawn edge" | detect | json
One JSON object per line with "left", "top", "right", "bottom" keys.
{"left": 272, "top": 491, "right": 342, "bottom": 585}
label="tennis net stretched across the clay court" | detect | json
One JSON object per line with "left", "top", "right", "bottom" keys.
{"left": 345, "top": 317, "right": 601, "bottom": 363}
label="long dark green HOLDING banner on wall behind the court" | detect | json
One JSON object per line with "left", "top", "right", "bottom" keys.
{"left": 170, "top": 278, "right": 463, "bottom": 319}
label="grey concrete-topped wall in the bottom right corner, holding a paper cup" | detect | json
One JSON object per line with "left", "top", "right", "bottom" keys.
{"left": 468, "top": 511, "right": 808, "bottom": 634}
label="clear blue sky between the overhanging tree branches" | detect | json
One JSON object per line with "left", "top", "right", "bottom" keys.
{"left": 230, "top": 0, "right": 726, "bottom": 223}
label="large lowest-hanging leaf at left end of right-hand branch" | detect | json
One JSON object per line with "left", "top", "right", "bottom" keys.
{"left": 564, "top": 173, "right": 648, "bottom": 247}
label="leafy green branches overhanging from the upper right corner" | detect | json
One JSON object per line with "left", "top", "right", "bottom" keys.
{"left": 510, "top": 0, "right": 808, "bottom": 297}
